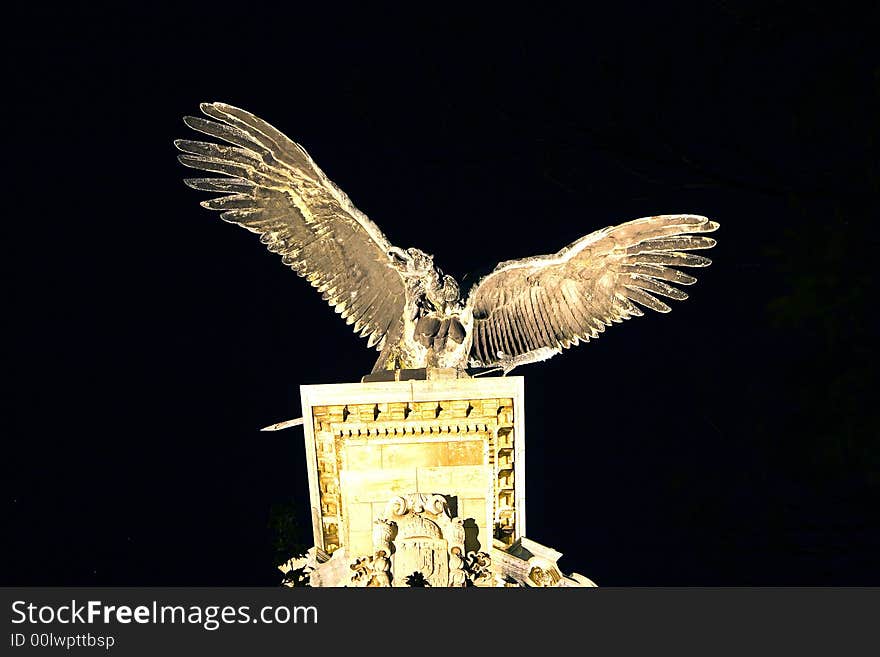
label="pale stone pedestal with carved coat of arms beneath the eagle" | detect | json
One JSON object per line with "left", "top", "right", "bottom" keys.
{"left": 280, "top": 371, "right": 595, "bottom": 587}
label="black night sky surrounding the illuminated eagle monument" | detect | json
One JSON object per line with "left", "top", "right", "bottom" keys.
{"left": 6, "top": 1, "right": 880, "bottom": 586}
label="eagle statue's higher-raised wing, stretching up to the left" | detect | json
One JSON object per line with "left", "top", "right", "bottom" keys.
{"left": 174, "top": 103, "right": 406, "bottom": 349}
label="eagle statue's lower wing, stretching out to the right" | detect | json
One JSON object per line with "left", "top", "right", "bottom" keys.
{"left": 468, "top": 214, "right": 718, "bottom": 369}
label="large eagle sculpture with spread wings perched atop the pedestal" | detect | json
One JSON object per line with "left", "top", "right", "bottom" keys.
{"left": 175, "top": 103, "right": 718, "bottom": 373}
